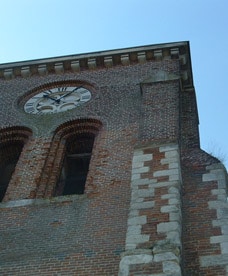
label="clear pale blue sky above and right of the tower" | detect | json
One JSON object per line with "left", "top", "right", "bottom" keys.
{"left": 0, "top": 0, "right": 228, "bottom": 167}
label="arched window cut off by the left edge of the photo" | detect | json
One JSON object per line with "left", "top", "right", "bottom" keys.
{"left": 0, "top": 126, "right": 32, "bottom": 201}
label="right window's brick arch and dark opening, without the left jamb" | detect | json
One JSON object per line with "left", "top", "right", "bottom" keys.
{"left": 55, "top": 119, "right": 102, "bottom": 196}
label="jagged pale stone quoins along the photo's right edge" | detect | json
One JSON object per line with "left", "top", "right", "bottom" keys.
{"left": 200, "top": 164, "right": 228, "bottom": 274}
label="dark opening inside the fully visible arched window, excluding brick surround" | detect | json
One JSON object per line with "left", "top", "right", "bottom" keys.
{"left": 56, "top": 134, "right": 94, "bottom": 196}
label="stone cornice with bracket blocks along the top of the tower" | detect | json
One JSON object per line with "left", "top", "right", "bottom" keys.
{"left": 0, "top": 41, "right": 193, "bottom": 87}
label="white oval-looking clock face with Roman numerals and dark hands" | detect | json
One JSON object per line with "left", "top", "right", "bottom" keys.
{"left": 24, "top": 86, "right": 91, "bottom": 114}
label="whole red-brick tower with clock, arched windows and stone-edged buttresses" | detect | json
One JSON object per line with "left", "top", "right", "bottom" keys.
{"left": 0, "top": 42, "right": 228, "bottom": 276}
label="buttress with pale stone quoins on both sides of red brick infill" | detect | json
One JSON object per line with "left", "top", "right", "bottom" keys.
{"left": 119, "top": 145, "right": 181, "bottom": 276}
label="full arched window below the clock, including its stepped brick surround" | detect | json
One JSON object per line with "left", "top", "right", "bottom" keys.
{"left": 36, "top": 118, "right": 102, "bottom": 198}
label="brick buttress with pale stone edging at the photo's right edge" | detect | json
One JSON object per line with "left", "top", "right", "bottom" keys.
{"left": 182, "top": 149, "right": 228, "bottom": 275}
